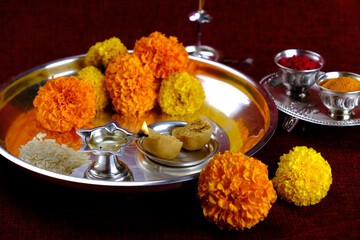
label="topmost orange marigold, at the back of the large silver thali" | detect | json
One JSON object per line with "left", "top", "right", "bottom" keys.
{"left": 134, "top": 32, "right": 189, "bottom": 78}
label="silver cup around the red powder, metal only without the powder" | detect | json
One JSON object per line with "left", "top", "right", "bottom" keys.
{"left": 274, "top": 49, "right": 325, "bottom": 99}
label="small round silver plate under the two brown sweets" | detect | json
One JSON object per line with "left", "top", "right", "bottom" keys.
{"left": 135, "top": 121, "right": 230, "bottom": 167}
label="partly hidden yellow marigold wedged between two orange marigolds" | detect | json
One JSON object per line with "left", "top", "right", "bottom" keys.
{"left": 78, "top": 66, "right": 108, "bottom": 111}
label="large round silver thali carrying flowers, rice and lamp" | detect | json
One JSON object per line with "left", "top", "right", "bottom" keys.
{"left": 0, "top": 55, "right": 278, "bottom": 192}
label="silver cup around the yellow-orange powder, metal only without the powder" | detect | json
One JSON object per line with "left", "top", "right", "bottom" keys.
{"left": 316, "top": 72, "right": 360, "bottom": 120}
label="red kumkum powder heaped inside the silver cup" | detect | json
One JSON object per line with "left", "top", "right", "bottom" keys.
{"left": 279, "top": 55, "right": 320, "bottom": 70}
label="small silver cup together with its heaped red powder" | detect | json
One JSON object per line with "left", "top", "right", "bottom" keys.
{"left": 274, "top": 49, "right": 325, "bottom": 99}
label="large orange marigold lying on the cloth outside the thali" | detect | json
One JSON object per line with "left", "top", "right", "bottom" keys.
{"left": 198, "top": 151, "right": 277, "bottom": 230}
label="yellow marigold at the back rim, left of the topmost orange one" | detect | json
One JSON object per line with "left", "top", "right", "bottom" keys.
{"left": 85, "top": 37, "right": 127, "bottom": 68}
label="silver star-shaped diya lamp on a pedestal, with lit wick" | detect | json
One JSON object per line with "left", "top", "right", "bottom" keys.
{"left": 76, "top": 122, "right": 145, "bottom": 181}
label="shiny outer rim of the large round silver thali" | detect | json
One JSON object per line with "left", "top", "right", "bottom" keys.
{"left": 0, "top": 54, "right": 278, "bottom": 192}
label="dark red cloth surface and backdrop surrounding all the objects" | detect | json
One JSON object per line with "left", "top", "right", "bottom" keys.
{"left": 0, "top": 0, "right": 360, "bottom": 239}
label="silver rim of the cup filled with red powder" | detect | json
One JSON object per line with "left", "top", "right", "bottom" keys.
{"left": 274, "top": 49, "right": 325, "bottom": 73}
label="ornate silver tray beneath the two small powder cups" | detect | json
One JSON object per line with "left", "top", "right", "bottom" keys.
{"left": 260, "top": 73, "right": 360, "bottom": 127}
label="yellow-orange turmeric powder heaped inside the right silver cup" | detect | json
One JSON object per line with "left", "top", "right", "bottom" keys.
{"left": 320, "top": 76, "right": 360, "bottom": 92}
